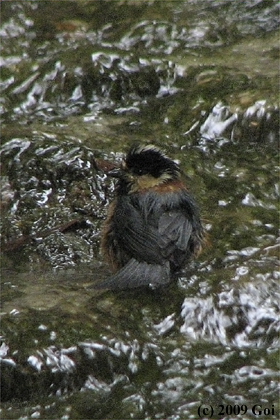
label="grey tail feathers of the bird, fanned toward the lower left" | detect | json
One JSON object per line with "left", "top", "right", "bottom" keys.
{"left": 94, "top": 258, "right": 170, "bottom": 290}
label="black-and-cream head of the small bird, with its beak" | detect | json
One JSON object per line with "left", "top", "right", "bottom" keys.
{"left": 108, "top": 145, "right": 180, "bottom": 192}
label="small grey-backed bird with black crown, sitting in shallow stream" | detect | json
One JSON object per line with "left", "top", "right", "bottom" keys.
{"left": 96, "top": 144, "right": 205, "bottom": 290}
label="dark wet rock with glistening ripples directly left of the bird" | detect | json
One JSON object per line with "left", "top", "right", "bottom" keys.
{"left": 1, "top": 138, "right": 109, "bottom": 267}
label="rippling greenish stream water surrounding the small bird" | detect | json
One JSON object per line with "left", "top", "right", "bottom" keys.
{"left": 0, "top": 0, "right": 280, "bottom": 420}
